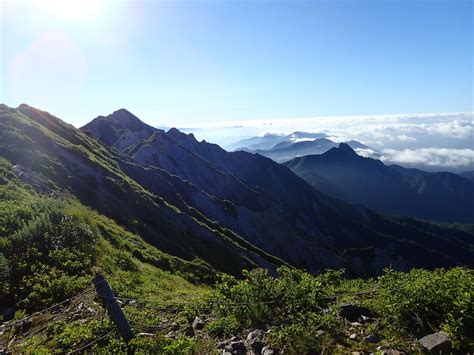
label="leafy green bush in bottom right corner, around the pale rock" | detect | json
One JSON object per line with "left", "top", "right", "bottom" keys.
{"left": 368, "top": 268, "right": 474, "bottom": 347}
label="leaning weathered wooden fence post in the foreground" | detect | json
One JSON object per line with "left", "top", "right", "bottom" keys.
{"left": 92, "top": 275, "right": 134, "bottom": 343}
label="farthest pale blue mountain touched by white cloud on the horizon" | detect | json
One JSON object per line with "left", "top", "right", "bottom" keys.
{"left": 226, "top": 131, "right": 327, "bottom": 151}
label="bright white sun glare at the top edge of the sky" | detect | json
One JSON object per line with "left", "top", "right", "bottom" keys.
{"left": 32, "top": 0, "right": 100, "bottom": 20}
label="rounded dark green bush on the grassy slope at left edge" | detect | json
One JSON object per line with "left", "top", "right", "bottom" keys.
{"left": 0, "top": 199, "right": 95, "bottom": 310}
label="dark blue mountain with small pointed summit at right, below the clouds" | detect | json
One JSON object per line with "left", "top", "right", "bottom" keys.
{"left": 285, "top": 144, "right": 474, "bottom": 223}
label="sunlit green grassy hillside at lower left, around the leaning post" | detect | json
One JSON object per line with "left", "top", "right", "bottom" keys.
{"left": 0, "top": 158, "right": 214, "bottom": 354}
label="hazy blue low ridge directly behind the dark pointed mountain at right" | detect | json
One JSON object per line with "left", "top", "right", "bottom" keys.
{"left": 255, "top": 138, "right": 370, "bottom": 163}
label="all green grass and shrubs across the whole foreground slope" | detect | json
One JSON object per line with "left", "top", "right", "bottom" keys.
{"left": 0, "top": 159, "right": 474, "bottom": 354}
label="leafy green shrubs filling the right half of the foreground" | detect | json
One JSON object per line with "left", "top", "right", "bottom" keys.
{"left": 198, "top": 267, "right": 474, "bottom": 354}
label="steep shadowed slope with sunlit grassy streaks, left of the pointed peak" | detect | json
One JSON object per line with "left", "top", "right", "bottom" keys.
{"left": 0, "top": 105, "right": 281, "bottom": 274}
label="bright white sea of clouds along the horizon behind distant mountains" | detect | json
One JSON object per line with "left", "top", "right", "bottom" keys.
{"left": 179, "top": 112, "right": 474, "bottom": 157}
